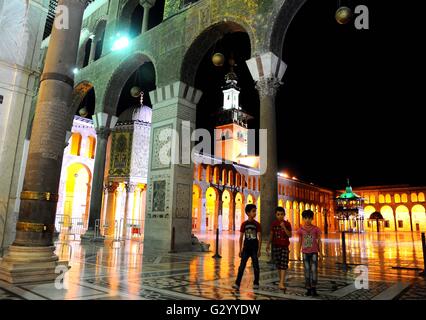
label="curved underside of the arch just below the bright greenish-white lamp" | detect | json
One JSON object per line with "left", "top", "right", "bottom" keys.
{"left": 103, "top": 51, "right": 157, "bottom": 115}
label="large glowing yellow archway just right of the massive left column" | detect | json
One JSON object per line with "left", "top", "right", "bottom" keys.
{"left": 64, "top": 163, "right": 92, "bottom": 227}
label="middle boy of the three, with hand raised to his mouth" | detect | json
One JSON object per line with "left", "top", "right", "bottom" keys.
{"left": 266, "top": 207, "right": 291, "bottom": 290}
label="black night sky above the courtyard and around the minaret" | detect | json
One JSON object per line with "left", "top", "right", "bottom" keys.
{"left": 196, "top": 0, "right": 426, "bottom": 189}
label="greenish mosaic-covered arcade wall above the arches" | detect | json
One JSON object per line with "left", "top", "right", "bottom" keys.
{"left": 75, "top": 0, "right": 306, "bottom": 115}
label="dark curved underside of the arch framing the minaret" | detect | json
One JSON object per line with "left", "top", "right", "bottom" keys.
{"left": 180, "top": 20, "right": 256, "bottom": 86}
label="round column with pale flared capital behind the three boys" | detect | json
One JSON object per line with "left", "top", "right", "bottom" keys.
{"left": 247, "top": 52, "right": 286, "bottom": 236}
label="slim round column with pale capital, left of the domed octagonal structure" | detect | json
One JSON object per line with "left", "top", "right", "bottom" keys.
{"left": 81, "top": 113, "right": 118, "bottom": 241}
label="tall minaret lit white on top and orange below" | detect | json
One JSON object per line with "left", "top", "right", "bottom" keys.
{"left": 215, "top": 59, "right": 252, "bottom": 162}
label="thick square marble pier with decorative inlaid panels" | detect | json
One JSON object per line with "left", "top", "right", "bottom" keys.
{"left": 144, "top": 82, "right": 201, "bottom": 251}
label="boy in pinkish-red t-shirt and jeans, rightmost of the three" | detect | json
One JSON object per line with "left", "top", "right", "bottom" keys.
{"left": 297, "top": 210, "right": 321, "bottom": 296}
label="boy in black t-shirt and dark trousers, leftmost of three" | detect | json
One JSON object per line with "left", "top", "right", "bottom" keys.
{"left": 232, "top": 204, "right": 262, "bottom": 290}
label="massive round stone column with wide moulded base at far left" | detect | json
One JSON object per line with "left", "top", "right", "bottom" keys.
{"left": 0, "top": 0, "right": 87, "bottom": 283}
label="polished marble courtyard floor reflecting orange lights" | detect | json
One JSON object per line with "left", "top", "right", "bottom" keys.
{"left": 0, "top": 232, "right": 426, "bottom": 300}
